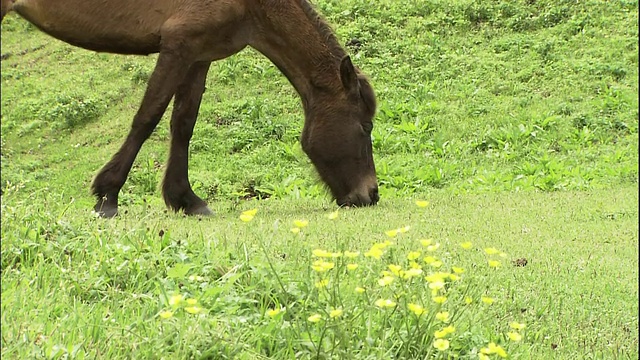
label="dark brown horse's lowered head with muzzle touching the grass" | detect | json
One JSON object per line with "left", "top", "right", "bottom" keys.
{"left": 301, "top": 56, "right": 380, "bottom": 206}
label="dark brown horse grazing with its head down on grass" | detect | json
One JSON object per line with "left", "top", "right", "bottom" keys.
{"left": 0, "top": 0, "right": 379, "bottom": 217}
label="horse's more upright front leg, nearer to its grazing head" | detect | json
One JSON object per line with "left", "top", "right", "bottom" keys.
{"left": 162, "top": 62, "right": 211, "bottom": 215}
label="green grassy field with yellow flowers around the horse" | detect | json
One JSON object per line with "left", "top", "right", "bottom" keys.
{"left": 0, "top": 0, "right": 638, "bottom": 359}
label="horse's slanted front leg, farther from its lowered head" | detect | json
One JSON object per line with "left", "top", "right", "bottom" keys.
{"left": 92, "top": 51, "right": 191, "bottom": 217}
